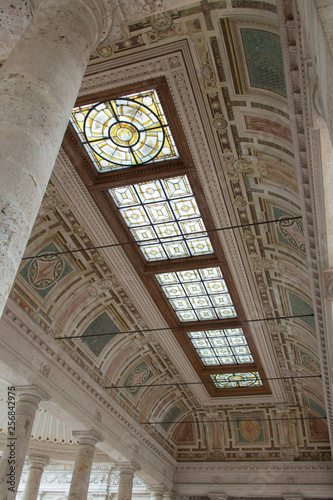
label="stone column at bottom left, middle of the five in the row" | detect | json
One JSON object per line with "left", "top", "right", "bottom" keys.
{"left": 68, "top": 430, "right": 103, "bottom": 500}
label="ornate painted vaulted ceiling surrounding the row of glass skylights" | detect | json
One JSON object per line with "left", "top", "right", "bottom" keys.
{"left": 1, "top": 0, "right": 331, "bottom": 461}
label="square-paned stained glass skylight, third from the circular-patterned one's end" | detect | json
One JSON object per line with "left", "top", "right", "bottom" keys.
{"left": 156, "top": 267, "right": 236, "bottom": 321}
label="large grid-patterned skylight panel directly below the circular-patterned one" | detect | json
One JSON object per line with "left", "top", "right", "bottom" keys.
{"left": 110, "top": 175, "right": 213, "bottom": 261}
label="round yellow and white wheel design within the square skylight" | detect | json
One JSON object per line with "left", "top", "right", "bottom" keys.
{"left": 83, "top": 98, "right": 165, "bottom": 166}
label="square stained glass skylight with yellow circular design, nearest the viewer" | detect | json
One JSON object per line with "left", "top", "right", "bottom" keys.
{"left": 71, "top": 90, "right": 178, "bottom": 172}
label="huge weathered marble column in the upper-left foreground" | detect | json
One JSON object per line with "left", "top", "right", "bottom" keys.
{"left": 0, "top": 0, "right": 113, "bottom": 316}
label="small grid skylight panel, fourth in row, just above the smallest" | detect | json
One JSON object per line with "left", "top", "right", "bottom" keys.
{"left": 187, "top": 328, "right": 253, "bottom": 366}
